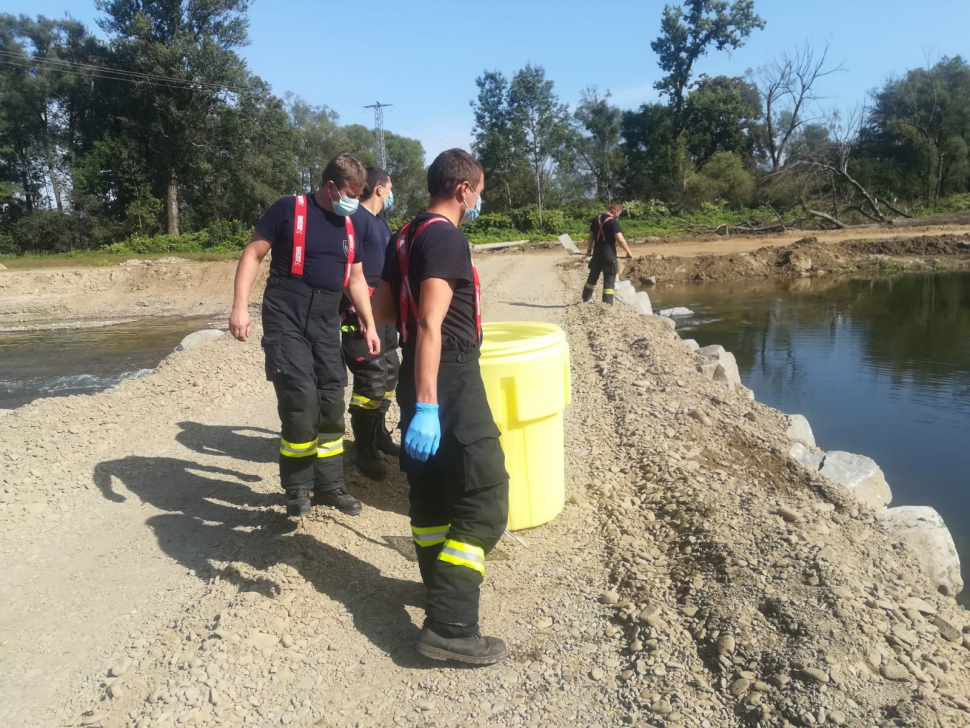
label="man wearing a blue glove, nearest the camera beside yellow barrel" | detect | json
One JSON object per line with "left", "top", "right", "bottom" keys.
{"left": 374, "top": 149, "right": 509, "bottom": 665}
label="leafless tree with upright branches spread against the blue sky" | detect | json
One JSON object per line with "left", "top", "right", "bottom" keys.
{"left": 758, "top": 42, "right": 845, "bottom": 172}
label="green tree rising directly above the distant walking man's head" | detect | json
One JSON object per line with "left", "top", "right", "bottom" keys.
{"left": 573, "top": 87, "right": 623, "bottom": 203}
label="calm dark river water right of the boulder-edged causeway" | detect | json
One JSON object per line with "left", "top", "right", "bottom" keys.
{"left": 650, "top": 273, "right": 970, "bottom": 594}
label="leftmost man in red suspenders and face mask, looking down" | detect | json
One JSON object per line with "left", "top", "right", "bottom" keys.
{"left": 229, "top": 154, "right": 380, "bottom": 516}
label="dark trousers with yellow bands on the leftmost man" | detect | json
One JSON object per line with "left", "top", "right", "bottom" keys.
{"left": 263, "top": 276, "right": 347, "bottom": 493}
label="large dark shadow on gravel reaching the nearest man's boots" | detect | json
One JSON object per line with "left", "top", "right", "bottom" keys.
{"left": 94, "top": 457, "right": 434, "bottom": 669}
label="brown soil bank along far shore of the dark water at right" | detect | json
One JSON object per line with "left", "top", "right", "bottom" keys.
{"left": 624, "top": 234, "right": 970, "bottom": 285}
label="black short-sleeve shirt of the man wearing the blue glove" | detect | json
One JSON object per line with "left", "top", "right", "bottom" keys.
{"left": 381, "top": 212, "right": 478, "bottom": 349}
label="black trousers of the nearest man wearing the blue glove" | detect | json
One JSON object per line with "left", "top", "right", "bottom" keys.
{"left": 397, "top": 345, "right": 509, "bottom": 637}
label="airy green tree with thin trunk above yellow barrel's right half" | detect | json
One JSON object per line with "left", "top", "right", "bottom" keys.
{"left": 509, "top": 63, "right": 571, "bottom": 222}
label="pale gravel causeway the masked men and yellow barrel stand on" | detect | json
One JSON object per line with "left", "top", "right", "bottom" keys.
{"left": 0, "top": 256, "right": 970, "bottom": 728}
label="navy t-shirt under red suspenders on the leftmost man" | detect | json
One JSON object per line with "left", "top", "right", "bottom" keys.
{"left": 256, "top": 195, "right": 358, "bottom": 291}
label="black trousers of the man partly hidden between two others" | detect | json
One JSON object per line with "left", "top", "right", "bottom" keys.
{"left": 342, "top": 323, "right": 401, "bottom": 414}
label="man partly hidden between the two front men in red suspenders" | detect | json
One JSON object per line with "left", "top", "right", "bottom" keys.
{"left": 340, "top": 167, "right": 401, "bottom": 480}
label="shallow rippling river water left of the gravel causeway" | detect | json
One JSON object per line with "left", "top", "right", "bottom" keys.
{"left": 0, "top": 316, "right": 221, "bottom": 409}
